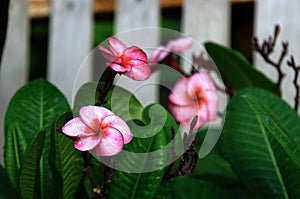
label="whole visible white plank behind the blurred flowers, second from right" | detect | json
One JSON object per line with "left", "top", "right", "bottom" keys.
{"left": 182, "top": 0, "right": 230, "bottom": 131}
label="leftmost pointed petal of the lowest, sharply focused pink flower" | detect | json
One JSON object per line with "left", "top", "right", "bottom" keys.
{"left": 62, "top": 117, "right": 94, "bottom": 137}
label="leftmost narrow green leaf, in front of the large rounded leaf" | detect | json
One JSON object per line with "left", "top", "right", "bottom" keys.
{"left": 4, "top": 123, "right": 27, "bottom": 190}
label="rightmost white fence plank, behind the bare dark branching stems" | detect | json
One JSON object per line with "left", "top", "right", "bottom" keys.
{"left": 254, "top": 0, "right": 300, "bottom": 113}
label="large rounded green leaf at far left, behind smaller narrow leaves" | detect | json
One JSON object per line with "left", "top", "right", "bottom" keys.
{"left": 5, "top": 79, "right": 70, "bottom": 198}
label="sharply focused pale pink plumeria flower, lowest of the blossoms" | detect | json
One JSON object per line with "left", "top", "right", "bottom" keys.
{"left": 62, "top": 106, "right": 132, "bottom": 156}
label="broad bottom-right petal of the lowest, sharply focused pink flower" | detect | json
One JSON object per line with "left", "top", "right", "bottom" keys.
{"left": 91, "top": 128, "right": 124, "bottom": 156}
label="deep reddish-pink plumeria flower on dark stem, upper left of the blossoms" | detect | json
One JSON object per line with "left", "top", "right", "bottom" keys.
{"left": 99, "top": 37, "right": 151, "bottom": 81}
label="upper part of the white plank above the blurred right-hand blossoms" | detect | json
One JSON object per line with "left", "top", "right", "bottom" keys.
{"left": 182, "top": 0, "right": 230, "bottom": 45}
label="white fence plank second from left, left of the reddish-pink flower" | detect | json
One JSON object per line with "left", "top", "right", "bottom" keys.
{"left": 48, "top": 0, "right": 93, "bottom": 105}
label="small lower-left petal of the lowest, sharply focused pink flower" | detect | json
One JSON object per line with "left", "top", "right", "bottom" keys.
{"left": 74, "top": 135, "right": 102, "bottom": 151}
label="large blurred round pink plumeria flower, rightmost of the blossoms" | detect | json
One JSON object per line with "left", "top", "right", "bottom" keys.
{"left": 169, "top": 72, "right": 218, "bottom": 130}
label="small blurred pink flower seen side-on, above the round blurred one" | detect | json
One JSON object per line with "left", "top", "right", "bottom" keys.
{"left": 150, "top": 36, "right": 193, "bottom": 64}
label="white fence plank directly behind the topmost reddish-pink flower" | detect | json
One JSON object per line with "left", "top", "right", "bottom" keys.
{"left": 115, "top": 0, "right": 160, "bottom": 105}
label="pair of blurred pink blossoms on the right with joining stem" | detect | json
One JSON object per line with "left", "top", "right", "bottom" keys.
{"left": 150, "top": 36, "right": 218, "bottom": 130}
